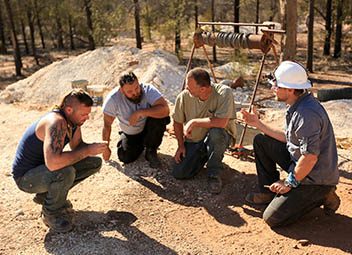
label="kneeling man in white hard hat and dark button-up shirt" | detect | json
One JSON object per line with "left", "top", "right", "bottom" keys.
{"left": 241, "top": 61, "right": 340, "bottom": 227}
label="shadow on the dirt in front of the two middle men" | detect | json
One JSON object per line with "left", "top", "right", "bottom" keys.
{"left": 110, "top": 154, "right": 261, "bottom": 227}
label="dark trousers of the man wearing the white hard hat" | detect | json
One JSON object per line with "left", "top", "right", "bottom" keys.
{"left": 253, "top": 134, "right": 335, "bottom": 227}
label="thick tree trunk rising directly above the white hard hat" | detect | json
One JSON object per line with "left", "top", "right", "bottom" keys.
{"left": 280, "top": 0, "right": 297, "bottom": 61}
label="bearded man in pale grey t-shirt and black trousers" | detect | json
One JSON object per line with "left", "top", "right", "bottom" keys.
{"left": 103, "top": 72, "right": 170, "bottom": 168}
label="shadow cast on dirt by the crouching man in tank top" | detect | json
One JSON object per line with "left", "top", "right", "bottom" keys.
{"left": 44, "top": 211, "right": 176, "bottom": 254}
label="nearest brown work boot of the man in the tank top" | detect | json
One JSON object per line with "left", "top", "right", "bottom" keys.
{"left": 42, "top": 211, "right": 73, "bottom": 233}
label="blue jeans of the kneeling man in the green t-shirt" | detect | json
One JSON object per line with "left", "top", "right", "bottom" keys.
{"left": 172, "top": 128, "right": 231, "bottom": 179}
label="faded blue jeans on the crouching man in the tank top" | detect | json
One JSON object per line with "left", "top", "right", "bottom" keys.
{"left": 16, "top": 157, "right": 102, "bottom": 214}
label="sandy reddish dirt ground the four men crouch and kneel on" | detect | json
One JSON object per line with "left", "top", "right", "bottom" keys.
{"left": 0, "top": 36, "right": 352, "bottom": 255}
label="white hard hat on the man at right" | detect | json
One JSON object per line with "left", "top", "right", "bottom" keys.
{"left": 269, "top": 61, "right": 312, "bottom": 89}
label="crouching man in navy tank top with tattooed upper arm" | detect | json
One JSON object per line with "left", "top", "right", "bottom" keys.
{"left": 12, "top": 90, "right": 107, "bottom": 232}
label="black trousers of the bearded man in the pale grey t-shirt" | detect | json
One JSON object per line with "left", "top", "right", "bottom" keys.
{"left": 117, "top": 116, "right": 170, "bottom": 164}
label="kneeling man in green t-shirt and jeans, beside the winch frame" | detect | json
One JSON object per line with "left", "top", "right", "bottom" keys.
{"left": 172, "top": 68, "right": 236, "bottom": 194}
